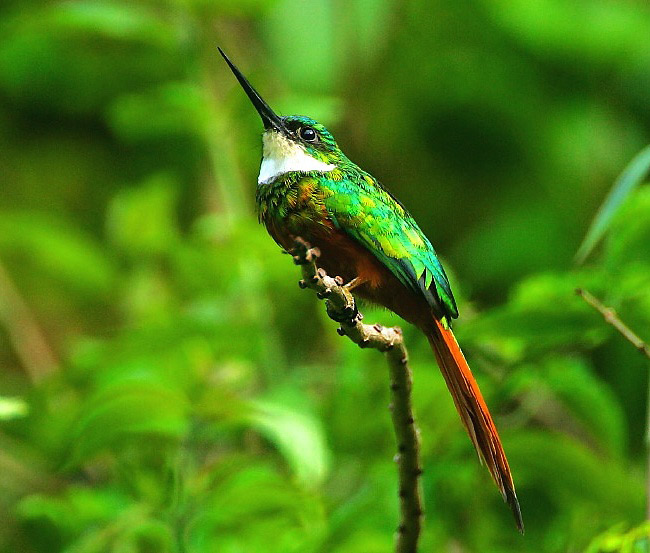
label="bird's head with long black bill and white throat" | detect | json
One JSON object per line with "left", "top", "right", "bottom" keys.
{"left": 219, "top": 48, "right": 347, "bottom": 184}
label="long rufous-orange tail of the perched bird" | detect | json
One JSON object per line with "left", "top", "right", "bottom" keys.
{"left": 427, "top": 319, "right": 524, "bottom": 534}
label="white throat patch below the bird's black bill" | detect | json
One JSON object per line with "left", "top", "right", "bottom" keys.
{"left": 257, "top": 130, "right": 336, "bottom": 184}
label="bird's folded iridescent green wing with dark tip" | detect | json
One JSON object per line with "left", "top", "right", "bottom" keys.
{"left": 321, "top": 172, "right": 458, "bottom": 318}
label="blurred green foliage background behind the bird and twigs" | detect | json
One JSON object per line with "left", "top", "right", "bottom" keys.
{"left": 0, "top": 0, "right": 650, "bottom": 553}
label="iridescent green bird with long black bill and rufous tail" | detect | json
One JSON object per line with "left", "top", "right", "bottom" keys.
{"left": 219, "top": 48, "right": 524, "bottom": 534}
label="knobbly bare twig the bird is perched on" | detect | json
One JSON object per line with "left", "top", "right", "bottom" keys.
{"left": 292, "top": 238, "right": 423, "bottom": 553}
